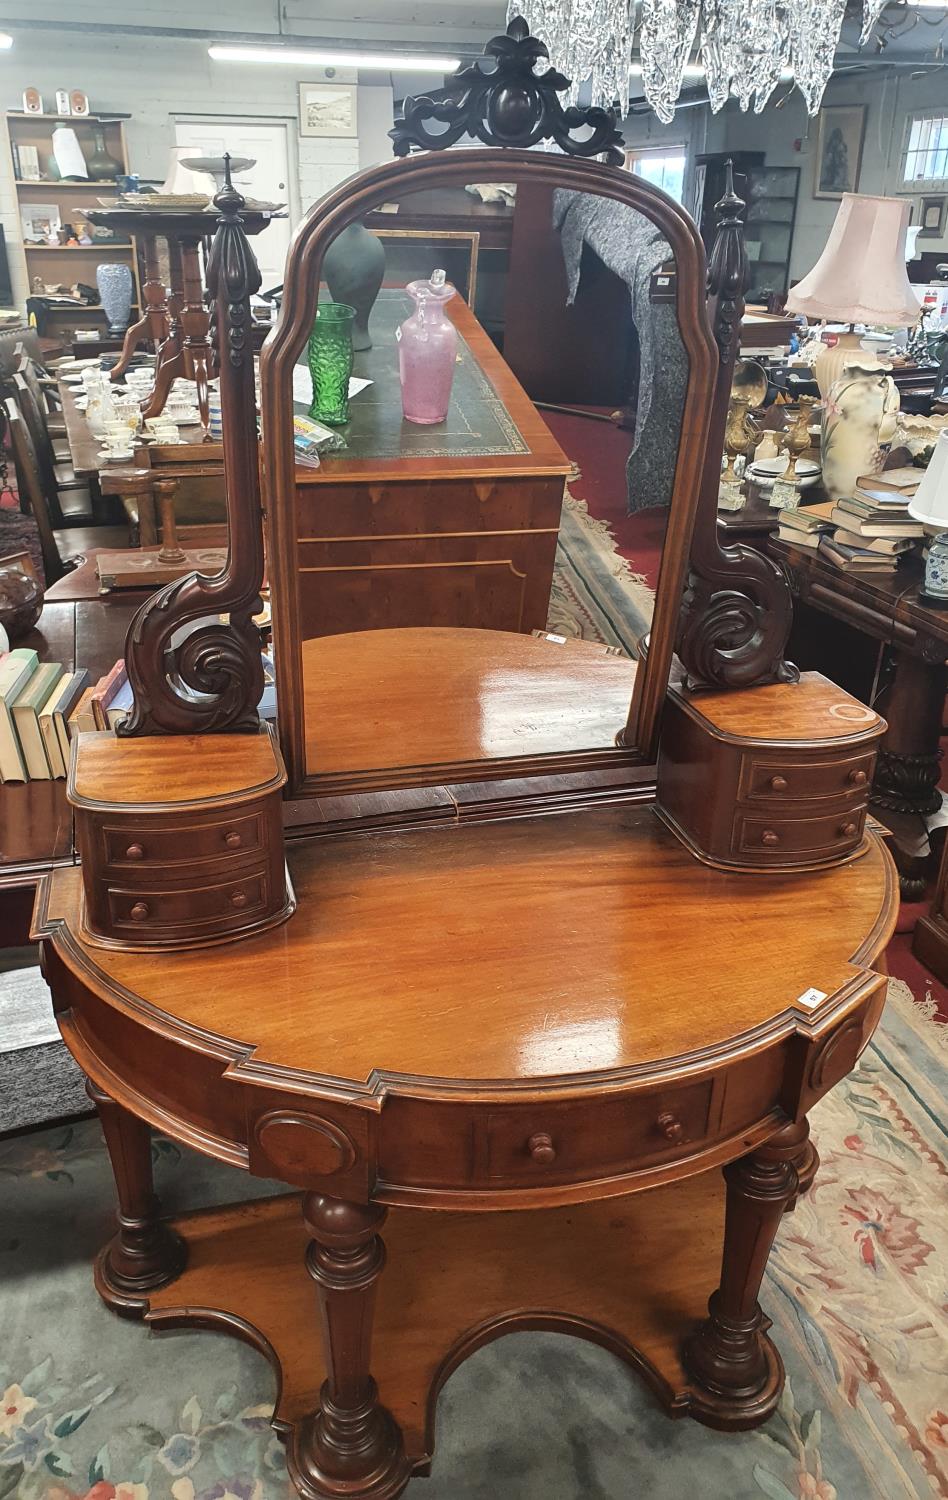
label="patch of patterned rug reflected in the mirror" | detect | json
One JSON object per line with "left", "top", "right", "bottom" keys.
{"left": 546, "top": 491, "right": 656, "bottom": 657}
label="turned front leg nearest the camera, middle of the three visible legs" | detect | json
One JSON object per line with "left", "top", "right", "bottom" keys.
{"left": 287, "top": 1193, "right": 411, "bottom": 1500}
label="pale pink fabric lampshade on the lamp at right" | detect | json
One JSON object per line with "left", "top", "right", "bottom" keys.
{"left": 786, "top": 192, "right": 921, "bottom": 329}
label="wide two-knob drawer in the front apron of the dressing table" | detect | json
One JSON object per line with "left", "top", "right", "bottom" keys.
{"left": 488, "top": 1082, "right": 711, "bottom": 1187}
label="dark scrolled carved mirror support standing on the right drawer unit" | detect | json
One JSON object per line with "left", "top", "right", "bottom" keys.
{"left": 677, "top": 164, "right": 800, "bottom": 689}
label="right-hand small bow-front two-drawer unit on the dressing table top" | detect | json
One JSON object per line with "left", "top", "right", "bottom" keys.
{"left": 657, "top": 672, "right": 885, "bottom": 870}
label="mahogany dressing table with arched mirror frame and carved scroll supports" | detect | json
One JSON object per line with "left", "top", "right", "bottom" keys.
{"left": 35, "top": 21, "right": 897, "bottom": 1500}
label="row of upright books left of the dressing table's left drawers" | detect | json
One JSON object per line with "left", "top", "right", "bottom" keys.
{"left": 0, "top": 648, "right": 132, "bottom": 782}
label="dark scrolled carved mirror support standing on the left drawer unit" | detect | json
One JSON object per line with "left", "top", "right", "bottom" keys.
{"left": 119, "top": 155, "right": 264, "bottom": 735}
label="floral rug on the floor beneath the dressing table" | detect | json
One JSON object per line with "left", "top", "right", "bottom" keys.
{"left": 0, "top": 981, "right": 948, "bottom": 1500}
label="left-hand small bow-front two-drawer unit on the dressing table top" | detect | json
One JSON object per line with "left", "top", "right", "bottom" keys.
{"left": 69, "top": 731, "right": 293, "bottom": 950}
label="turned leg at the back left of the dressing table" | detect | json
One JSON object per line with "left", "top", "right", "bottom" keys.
{"left": 87, "top": 1083, "right": 186, "bottom": 1313}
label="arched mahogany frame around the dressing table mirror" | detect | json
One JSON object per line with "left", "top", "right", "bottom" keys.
{"left": 261, "top": 147, "right": 719, "bottom": 797}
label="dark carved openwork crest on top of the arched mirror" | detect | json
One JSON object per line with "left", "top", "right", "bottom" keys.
{"left": 389, "top": 17, "right": 624, "bottom": 167}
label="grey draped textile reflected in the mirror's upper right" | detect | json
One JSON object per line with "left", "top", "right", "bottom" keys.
{"left": 554, "top": 188, "right": 689, "bottom": 513}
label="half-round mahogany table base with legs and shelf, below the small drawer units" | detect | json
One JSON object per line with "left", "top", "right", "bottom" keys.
{"left": 35, "top": 803, "right": 897, "bottom": 1500}
